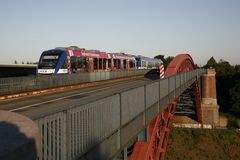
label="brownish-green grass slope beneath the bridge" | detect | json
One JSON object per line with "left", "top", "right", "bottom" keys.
{"left": 166, "top": 128, "right": 240, "bottom": 160}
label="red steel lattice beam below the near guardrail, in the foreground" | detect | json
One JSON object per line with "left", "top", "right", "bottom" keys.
{"left": 130, "top": 101, "right": 176, "bottom": 160}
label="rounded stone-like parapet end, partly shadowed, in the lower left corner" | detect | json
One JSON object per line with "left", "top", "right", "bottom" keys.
{"left": 0, "top": 111, "right": 40, "bottom": 160}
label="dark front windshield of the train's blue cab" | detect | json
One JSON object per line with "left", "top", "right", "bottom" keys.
{"left": 39, "top": 53, "right": 61, "bottom": 69}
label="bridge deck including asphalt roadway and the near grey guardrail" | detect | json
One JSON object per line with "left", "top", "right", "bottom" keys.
{"left": 0, "top": 70, "right": 203, "bottom": 159}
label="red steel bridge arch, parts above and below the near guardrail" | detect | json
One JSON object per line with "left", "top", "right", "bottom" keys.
{"left": 131, "top": 54, "right": 202, "bottom": 160}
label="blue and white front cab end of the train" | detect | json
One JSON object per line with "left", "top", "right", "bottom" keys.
{"left": 37, "top": 49, "right": 69, "bottom": 75}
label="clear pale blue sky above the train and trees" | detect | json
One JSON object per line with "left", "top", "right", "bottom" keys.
{"left": 0, "top": 0, "right": 240, "bottom": 65}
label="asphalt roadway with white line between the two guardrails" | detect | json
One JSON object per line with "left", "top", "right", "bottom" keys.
{"left": 0, "top": 77, "right": 155, "bottom": 119}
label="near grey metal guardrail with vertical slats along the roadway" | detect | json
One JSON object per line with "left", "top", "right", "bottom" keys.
{"left": 32, "top": 70, "right": 205, "bottom": 160}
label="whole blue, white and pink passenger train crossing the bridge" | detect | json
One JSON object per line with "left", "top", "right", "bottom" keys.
{"left": 37, "top": 46, "right": 162, "bottom": 75}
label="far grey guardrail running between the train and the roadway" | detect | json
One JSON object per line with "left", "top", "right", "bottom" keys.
{"left": 0, "top": 70, "right": 149, "bottom": 96}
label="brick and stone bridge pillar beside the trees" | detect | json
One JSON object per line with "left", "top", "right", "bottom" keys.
{"left": 201, "top": 68, "right": 219, "bottom": 127}
